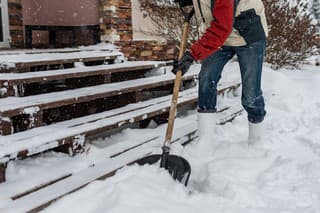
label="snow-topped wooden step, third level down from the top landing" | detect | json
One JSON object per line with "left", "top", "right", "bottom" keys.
{"left": 0, "top": 71, "right": 197, "bottom": 135}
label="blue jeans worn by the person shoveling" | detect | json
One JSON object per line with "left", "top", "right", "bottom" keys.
{"left": 199, "top": 40, "right": 266, "bottom": 123}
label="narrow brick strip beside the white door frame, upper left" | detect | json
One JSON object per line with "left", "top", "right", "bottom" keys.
{"left": 8, "top": 0, "right": 24, "bottom": 48}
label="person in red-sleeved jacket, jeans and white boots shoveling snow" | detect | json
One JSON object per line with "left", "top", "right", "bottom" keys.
{"left": 173, "top": 0, "right": 268, "bottom": 147}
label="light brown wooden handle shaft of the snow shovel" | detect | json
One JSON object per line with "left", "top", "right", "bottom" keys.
{"left": 164, "top": 22, "right": 190, "bottom": 147}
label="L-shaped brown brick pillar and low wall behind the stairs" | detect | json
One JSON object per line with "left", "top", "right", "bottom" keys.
{"left": 99, "top": 0, "right": 176, "bottom": 60}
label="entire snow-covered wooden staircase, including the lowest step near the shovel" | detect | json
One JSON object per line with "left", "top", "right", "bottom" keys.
{"left": 0, "top": 48, "right": 242, "bottom": 212}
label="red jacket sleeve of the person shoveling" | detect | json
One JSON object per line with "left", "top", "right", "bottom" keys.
{"left": 190, "top": 0, "right": 234, "bottom": 60}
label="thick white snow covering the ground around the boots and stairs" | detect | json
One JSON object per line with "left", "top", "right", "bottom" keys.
{"left": 0, "top": 60, "right": 320, "bottom": 213}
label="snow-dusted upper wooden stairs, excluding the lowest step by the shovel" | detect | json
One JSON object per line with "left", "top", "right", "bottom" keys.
{"left": 0, "top": 48, "right": 210, "bottom": 182}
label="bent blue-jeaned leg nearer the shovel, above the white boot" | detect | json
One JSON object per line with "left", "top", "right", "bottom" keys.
{"left": 198, "top": 47, "right": 235, "bottom": 113}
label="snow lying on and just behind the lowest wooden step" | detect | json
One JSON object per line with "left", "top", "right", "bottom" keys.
{"left": 0, "top": 117, "right": 199, "bottom": 212}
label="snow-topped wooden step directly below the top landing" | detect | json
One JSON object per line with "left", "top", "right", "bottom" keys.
{"left": 0, "top": 61, "right": 167, "bottom": 97}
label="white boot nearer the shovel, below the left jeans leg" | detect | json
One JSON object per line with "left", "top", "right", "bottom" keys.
{"left": 196, "top": 113, "right": 217, "bottom": 155}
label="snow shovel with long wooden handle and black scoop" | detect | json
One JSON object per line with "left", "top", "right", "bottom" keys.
{"left": 137, "top": 7, "right": 194, "bottom": 186}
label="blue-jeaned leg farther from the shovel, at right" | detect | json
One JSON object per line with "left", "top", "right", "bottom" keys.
{"left": 235, "top": 41, "right": 266, "bottom": 124}
